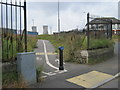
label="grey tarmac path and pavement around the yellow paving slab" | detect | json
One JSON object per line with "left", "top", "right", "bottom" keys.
{"left": 31, "top": 40, "right": 120, "bottom": 89}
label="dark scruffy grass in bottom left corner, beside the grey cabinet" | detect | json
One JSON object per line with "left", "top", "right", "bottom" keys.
{"left": 2, "top": 71, "right": 28, "bottom": 88}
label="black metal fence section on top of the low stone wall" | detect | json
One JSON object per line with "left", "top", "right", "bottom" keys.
{"left": 86, "top": 13, "right": 112, "bottom": 50}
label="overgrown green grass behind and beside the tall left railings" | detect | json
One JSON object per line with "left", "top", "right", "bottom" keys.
{"left": 2, "top": 36, "right": 37, "bottom": 62}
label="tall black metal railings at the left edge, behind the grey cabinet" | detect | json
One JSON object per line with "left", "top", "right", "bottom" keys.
{"left": 0, "top": 0, "right": 27, "bottom": 62}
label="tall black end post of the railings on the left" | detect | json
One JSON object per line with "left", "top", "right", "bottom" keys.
{"left": 24, "top": 0, "right": 27, "bottom": 52}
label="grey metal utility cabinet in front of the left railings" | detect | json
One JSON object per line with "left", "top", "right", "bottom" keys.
{"left": 17, "top": 52, "right": 37, "bottom": 85}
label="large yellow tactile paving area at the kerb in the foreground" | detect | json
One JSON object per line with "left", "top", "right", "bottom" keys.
{"left": 67, "top": 71, "right": 113, "bottom": 88}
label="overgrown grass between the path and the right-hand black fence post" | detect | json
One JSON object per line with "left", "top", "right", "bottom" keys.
{"left": 38, "top": 34, "right": 83, "bottom": 61}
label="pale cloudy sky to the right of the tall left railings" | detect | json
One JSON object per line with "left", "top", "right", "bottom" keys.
{"left": 28, "top": 1, "right": 118, "bottom": 34}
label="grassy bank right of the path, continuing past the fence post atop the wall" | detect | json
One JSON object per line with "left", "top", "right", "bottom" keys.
{"left": 38, "top": 33, "right": 114, "bottom": 62}
